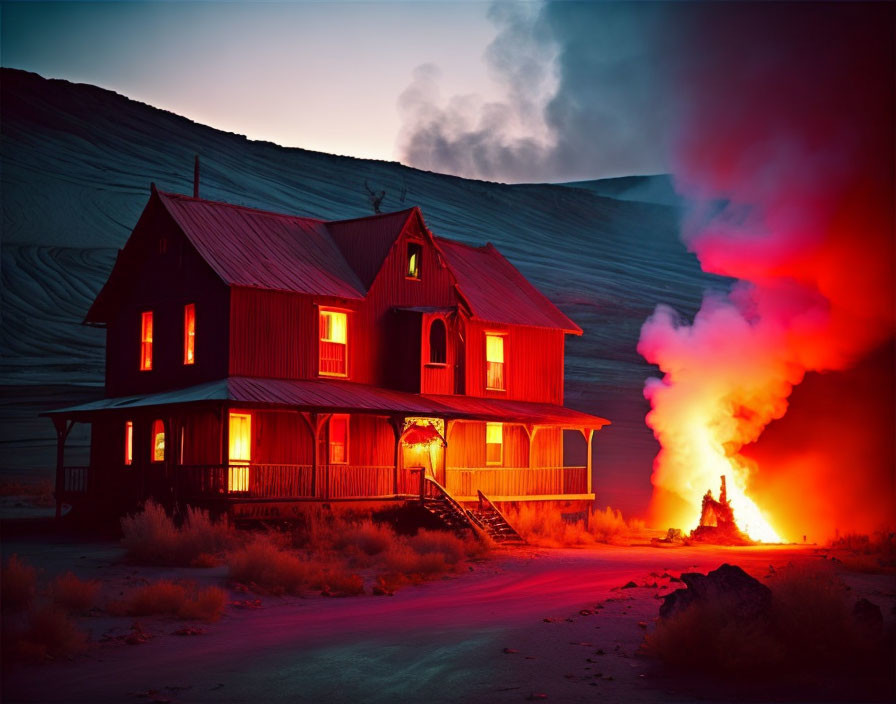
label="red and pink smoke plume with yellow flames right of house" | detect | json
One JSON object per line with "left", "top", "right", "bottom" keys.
{"left": 638, "top": 3, "right": 896, "bottom": 539}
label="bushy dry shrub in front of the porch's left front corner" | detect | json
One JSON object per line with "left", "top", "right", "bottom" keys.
{"left": 121, "top": 501, "right": 235, "bottom": 567}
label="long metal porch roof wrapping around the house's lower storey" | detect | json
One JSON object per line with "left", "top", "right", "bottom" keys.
{"left": 41, "top": 376, "right": 610, "bottom": 429}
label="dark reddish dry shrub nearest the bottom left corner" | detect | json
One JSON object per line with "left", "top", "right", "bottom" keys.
{"left": 3, "top": 606, "right": 87, "bottom": 661}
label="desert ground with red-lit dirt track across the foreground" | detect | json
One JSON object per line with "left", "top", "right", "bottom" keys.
{"left": 2, "top": 524, "right": 896, "bottom": 703}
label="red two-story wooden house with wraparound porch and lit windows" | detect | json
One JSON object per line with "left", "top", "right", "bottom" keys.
{"left": 47, "top": 186, "right": 607, "bottom": 516}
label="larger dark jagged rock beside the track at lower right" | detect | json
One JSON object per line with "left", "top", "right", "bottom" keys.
{"left": 660, "top": 564, "right": 772, "bottom": 620}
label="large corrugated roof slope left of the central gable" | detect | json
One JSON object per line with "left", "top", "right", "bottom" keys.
{"left": 158, "top": 191, "right": 367, "bottom": 299}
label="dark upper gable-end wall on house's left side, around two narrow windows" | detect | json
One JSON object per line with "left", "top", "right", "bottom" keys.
{"left": 106, "top": 202, "right": 230, "bottom": 396}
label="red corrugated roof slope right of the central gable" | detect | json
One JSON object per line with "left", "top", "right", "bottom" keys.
{"left": 435, "top": 237, "right": 582, "bottom": 335}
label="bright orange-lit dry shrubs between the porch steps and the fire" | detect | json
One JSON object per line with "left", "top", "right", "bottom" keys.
{"left": 507, "top": 504, "right": 644, "bottom": 547}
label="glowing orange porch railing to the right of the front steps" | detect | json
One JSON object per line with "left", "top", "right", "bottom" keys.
{"left": 445, "top": 467, "right": 588, "bottom": 498}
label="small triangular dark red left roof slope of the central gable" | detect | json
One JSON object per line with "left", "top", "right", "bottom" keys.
{"left": 326, "top": 208, "right": 414, "bottom": 289}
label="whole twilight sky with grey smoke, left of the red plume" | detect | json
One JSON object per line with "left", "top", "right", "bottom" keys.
{"left": 0, "top": 1, "right": 669, "bottom": 181}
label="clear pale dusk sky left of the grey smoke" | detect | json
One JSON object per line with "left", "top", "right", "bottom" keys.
{"left": 0, "top": 2, "right": 498, "bottom": 165}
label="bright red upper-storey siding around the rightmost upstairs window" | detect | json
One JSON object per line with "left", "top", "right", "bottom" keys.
{"left": 465, "top": 320, "right": 564, "bottom": 404}
